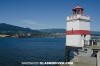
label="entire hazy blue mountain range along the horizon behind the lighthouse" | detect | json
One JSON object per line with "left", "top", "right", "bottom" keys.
{"left": 0, "top": 23, "right": 100, "bottom": 35}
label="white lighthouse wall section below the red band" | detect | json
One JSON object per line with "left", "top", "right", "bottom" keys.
{"left": 66, "top": 35, "right": 90, "bottom": 47}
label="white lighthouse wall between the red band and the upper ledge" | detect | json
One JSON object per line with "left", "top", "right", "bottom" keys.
{"left": 67, "top": 20, "right": 90, "bottom": 31}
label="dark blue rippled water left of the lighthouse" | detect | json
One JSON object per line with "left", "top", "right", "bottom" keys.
{"left": 0, "top": 38, "right": 65, "bottom": 66}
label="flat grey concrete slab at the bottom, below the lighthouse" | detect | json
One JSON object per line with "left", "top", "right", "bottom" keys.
{"left": 70, "top": 56, "right": 96, "bottom": 66}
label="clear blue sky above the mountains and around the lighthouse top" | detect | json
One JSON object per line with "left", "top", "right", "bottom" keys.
{"left": 0, "top": 0, "right": 100, "bottom": 31}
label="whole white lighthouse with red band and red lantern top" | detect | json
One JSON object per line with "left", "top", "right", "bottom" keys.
{"left": 66, "top": 5, "right": 90, "bottom": 61}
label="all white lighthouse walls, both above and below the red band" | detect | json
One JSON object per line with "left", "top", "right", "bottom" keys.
{"left": 66, "top": 15, "right": 90, "bottom": 47}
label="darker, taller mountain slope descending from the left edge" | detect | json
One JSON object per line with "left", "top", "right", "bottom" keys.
{"left": 0, "top": 23, "right": 40, "bottom": 33}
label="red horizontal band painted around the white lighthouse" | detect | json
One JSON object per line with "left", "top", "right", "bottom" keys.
{"left": 66, "top": 30, "right": 90, "bottom": 35}
